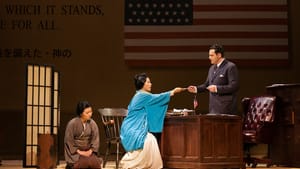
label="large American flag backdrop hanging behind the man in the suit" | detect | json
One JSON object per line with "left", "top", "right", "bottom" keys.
{"left": 124, "top": 0, "right": 289, "bottom": 66}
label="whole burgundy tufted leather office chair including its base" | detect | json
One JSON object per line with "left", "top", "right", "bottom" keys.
{"left": 242, "top": 96, "right": 276, "bottom": 168}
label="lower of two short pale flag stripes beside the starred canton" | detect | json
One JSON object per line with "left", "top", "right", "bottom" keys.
{"left": 194, "top": 11, "right": 287, "bottom": 19}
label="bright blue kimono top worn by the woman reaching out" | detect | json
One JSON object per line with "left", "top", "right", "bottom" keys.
{"left": 121, "top": 91, "right": 170, "bottom": 152}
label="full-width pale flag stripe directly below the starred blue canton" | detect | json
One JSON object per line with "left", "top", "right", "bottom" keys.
{"left": 124, "top": 25, "right": 288, "bottom": 33}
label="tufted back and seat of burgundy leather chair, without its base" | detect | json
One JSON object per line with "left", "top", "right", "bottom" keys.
{"left": 242, "top": 96, "right": 276, "bottom": 143}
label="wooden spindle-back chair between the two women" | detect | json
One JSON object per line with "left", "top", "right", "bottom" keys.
{"left": 98, "top": 108, "right": 127, "bottom": 169}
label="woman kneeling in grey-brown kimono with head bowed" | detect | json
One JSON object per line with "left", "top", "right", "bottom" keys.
{"left": 64, "top": 101, "right": 102, "bottom": 169}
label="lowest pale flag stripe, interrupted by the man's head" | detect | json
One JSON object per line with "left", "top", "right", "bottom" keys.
{"left": 125, "top": 52, "right": 288, "bottom": 62}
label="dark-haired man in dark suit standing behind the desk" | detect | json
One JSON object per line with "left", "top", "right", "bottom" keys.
{"left": 188, "top": 44, "right": 239, "bottom": 115}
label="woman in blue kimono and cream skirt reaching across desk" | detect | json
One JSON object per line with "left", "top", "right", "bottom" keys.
{"left": 120, "top": 73, "right": 185, "bottom": 169}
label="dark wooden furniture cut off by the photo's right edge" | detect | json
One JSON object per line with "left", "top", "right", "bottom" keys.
{"left": 266, "top": 84, "right": 300, "bottom": 167}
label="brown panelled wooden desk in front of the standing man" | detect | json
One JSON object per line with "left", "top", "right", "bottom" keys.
{"left": 161, "top": 115, "right": 245, "bottom": 169}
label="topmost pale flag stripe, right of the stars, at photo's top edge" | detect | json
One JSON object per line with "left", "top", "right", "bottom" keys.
{"left": 193, "top": 0, "right": 287, "bottom": 5}
